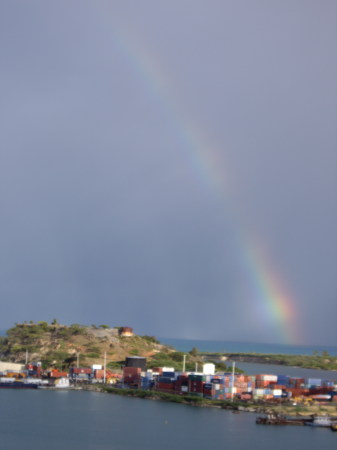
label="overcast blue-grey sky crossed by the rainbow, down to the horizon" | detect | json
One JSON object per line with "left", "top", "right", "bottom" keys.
{"left": 0, "top": 0, "right": 337, "bottom": 345}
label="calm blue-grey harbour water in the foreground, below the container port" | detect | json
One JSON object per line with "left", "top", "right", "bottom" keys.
{"left": 0, "top": 390, "right": 336, "bottom": 450}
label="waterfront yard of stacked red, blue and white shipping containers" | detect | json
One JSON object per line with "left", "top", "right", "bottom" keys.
{"left": 0, "top": 357, "right": 337, "bottom": 407}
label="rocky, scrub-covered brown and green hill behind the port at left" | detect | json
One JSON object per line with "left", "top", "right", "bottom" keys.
{"left": 0, "top": 320, "right": 176, "bottom": 368}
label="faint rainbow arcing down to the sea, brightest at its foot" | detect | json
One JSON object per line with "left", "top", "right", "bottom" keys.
{"left": 94, "top": 13, "right": 301, "bottom": 345}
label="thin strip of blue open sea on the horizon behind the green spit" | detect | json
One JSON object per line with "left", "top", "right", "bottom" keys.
{"left": 158, "top": 338, "right": 337, "bottom": 356}
